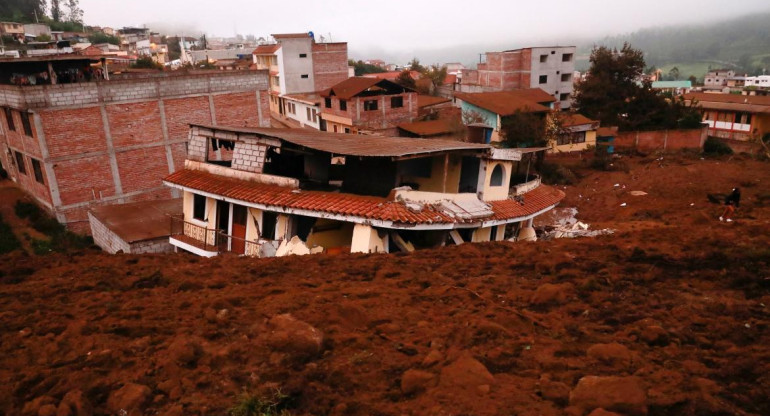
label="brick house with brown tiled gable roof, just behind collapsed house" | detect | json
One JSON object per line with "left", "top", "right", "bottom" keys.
{"left": 320, "top": 77, "right": 419, "bottom": 136}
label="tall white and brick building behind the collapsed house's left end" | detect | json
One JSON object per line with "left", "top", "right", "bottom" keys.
{"left": 252, "top": 33, "right": 348, "bottom": 127}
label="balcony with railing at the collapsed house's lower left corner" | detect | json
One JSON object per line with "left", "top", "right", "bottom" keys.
{"left": 170, "top": 216, "right": 263, "bottom": 257}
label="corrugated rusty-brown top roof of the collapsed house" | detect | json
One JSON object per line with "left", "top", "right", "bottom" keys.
{"left": 192, "top": 124, "right": 492, "bottom": 157}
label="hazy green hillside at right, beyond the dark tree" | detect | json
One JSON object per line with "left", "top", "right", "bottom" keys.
{"left": 588, "top": 12, "right": 770, "bottom": 79}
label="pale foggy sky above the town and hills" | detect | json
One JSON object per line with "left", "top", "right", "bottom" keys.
{"left": 80, "top": 0, "right": 770, "bottom": 62}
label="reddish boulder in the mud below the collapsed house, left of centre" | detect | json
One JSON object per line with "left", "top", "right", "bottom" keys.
{"left": 268, "top": 313, "right": 324, "bottom": 357}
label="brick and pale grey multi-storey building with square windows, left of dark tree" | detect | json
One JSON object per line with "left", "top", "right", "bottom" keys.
{"left": 457, "top": 46, "right": 577, "bottom": 109}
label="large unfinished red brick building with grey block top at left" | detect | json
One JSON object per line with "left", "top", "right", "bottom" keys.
{"left": 0, "top": 56, "right": 270, "bottom": 231}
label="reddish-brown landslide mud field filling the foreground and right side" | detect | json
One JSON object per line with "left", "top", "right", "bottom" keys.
{"left": 0, "top": 156, "right": 770, "bottom": 416}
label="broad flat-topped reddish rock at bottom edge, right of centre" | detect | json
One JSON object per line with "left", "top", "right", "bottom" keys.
{"left": 569, "top": 376, "right": 647, "bottom": 416}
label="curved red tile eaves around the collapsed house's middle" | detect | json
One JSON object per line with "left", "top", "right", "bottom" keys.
{"left": 164, "top": 169, "right": 564, "bottom": 225}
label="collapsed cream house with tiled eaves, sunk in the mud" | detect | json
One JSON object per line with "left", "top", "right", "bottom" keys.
{"left": 163, "top": 125, "right": 564, "bottom": 257}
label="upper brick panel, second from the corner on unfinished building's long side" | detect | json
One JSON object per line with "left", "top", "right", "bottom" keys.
{"left": 106, "top": 101, "right": 163, "bottom": 148}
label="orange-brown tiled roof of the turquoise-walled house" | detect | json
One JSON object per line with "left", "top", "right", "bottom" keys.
{"left": 455, "top": 88, "right": 556, "bottom": 116}
